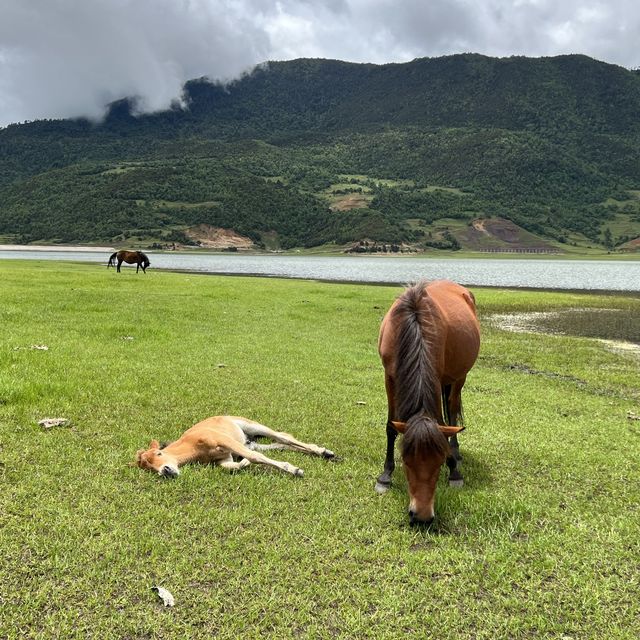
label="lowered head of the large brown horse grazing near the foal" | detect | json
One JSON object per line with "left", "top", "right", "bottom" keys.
{"left": 393, "top": 415, "right": 463, "bottom": 525}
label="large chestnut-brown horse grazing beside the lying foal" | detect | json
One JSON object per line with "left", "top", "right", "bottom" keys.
{"left": 376, "top": 280, "right": 480, "bottom": 524}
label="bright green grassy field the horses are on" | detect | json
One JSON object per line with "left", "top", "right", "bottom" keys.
{"left": 0, "top": 260, "right": 640, "bottom": 639}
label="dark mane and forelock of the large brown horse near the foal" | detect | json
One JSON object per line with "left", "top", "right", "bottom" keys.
{"left": 394, "top": 281, "right": 449, "bottom": 453}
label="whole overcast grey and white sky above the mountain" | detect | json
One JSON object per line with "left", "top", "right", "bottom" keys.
{"left": 0, "top": 0, "right": 640, "bottom": 126}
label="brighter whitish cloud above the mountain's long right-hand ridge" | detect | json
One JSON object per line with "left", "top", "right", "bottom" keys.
{"left": 268, "top": 0, "right": 640, "bottom": 67}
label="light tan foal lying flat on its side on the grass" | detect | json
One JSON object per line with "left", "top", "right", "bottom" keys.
{"left": 136, "top": 416, "right": 335, "bottom": 478}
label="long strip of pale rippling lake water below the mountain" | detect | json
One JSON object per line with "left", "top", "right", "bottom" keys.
{"left": 0, "top": 250, "right": 640, "bottom": 291}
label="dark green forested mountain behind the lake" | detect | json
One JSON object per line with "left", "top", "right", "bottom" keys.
{"left": 0, "top": 54, "right": 640, "bottom": 251}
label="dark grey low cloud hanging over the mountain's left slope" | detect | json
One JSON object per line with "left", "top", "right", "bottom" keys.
{"left": 0, "top": 0, "right": 269, "bottom": 124}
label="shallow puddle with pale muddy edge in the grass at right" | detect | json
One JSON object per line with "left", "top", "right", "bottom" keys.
{"left": 488, "top": 308, "right": 640, "bottom": 356}
